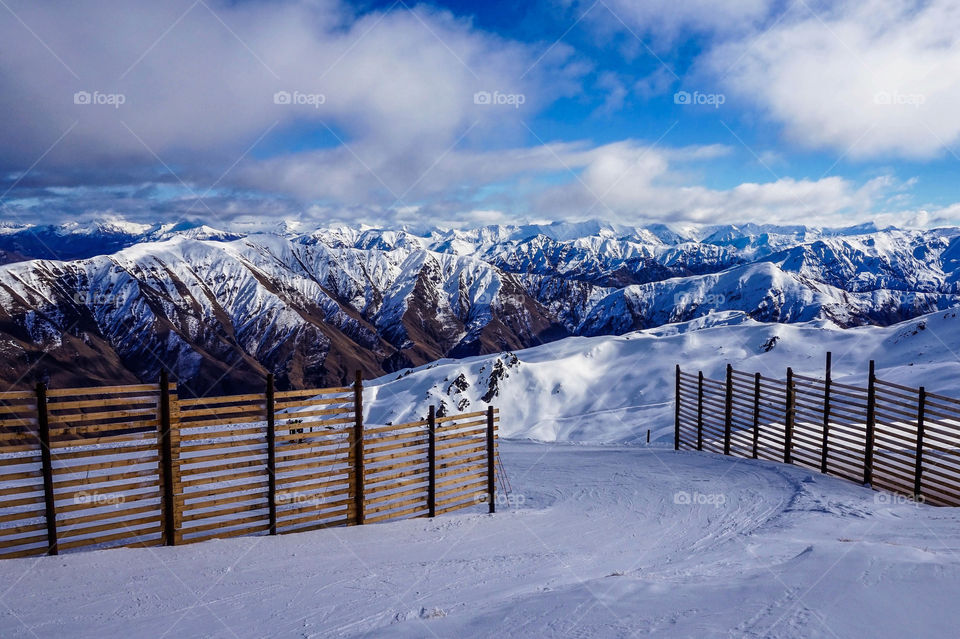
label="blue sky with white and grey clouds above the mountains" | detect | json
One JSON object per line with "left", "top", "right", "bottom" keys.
{"left": 0, "top": 0, "right": 960, "bottom": 226}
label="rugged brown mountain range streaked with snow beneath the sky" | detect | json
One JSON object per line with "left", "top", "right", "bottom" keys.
{"left": 0, "top": 221, "right": 960, "bottom": 394}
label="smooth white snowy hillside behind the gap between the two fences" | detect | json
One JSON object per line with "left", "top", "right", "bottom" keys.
{"left": 367, "top": 311, "right": 960, "bottom": 442}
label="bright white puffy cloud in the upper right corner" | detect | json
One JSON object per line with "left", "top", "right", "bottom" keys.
{"left": 705, "top": 0, "right": 960, "bottom": 159}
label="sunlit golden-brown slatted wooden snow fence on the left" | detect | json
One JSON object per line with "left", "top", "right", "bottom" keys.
{"left": 0, "top": 374, "right": 500, "bottom": 558}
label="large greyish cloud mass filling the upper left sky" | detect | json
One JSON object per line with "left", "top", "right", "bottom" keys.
{"left": 0, "top": 0, "right": 565, "bottom": 168}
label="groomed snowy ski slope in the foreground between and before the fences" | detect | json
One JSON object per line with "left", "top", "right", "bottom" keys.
{"left": 0, "top": 441, "right": 960, "bottom": 639}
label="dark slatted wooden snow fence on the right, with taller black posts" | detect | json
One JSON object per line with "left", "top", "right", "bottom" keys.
{"left": 674, "top": 353, "right": 960, "bottom": 506}
